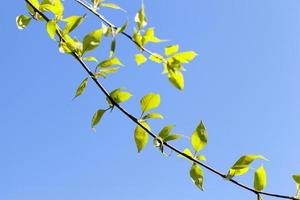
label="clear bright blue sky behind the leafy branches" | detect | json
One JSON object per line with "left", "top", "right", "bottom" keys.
{"left": 0, "top": 0, "right": 300, "bottom": 200}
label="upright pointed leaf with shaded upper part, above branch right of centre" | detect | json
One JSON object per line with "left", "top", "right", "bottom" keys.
{"left": 191, "top": 121, "right": 208, "bottom": 152}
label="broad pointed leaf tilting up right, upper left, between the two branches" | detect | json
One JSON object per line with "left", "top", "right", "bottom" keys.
{"left": 82, "top": 28, "right": 102, "bottom": 54}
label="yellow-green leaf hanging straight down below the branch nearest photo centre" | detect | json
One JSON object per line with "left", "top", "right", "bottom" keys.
{"left": 134, "top": 122, "right": 150, "bottom": 153}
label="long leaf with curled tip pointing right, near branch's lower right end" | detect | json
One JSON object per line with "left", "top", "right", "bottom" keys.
{"left": 227, "top": 154, "right": 267, "bottom": 179}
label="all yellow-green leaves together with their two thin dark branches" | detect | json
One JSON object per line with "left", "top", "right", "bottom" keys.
{"left": 16, "top": 0, "right": 300, "bottom": 199}
